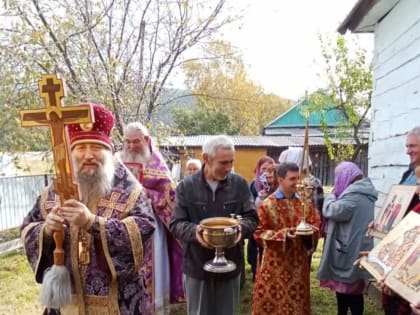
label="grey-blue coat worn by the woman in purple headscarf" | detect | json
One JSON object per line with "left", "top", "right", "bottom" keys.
{"left": 317, "top": 178, "right": 378, "bottom": 283}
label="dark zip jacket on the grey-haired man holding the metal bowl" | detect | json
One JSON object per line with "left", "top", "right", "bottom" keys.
{"left": 169, "top": 170, "right": 258, "bottom": 280}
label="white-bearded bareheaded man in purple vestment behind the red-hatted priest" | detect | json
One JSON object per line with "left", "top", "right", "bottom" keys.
{"left": 116, "top": 122, "right": 184, "bottom": 314}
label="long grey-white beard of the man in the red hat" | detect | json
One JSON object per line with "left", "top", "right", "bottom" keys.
{"left": 74, "top": 150, "right": 116, "bottom": 205}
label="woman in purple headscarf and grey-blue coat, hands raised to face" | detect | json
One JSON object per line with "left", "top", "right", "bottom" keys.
{"left": 317, "top": 162, "right": 378, "bottom": 315}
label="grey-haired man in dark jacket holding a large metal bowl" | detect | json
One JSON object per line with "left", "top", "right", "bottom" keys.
{"left": 170, "top": 136, "right": 258, "bottom": 315}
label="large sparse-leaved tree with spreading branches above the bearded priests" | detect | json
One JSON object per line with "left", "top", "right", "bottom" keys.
{"left": 0, "top": 0, "right": 233, "bottom": 151}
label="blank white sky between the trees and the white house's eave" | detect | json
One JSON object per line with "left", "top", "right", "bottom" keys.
{"left": 223, "top": 0, "right": 373, "bottom": 100}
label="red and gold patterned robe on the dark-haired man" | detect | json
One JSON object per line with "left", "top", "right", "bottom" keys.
{"left": 252, "top": 192, "right": 321, "bottom": 315}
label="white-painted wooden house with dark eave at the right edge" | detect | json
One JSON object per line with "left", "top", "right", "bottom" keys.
{"left": 338, "top": 0, "right": 420, "bottom": 202}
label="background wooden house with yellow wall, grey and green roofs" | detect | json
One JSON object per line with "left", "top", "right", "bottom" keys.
{"left": 159, "top": 97, "right": 368, "bottom": 185}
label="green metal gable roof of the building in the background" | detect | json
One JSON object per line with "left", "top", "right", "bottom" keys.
{"left": 265, "top": 99, "right": 345, "bottom": 128}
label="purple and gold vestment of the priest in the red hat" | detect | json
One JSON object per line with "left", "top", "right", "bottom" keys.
{"left": 21, "top": 164, "right": 156, "bottom": 315}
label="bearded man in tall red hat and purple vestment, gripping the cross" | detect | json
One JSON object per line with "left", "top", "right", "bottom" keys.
{"left": 21, "top": 104, "right": 155, "bottom": 315}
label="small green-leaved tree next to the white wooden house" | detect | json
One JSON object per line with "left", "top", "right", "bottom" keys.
{"left": 309, "top": 36, "right": 372, "bottom": 161}
